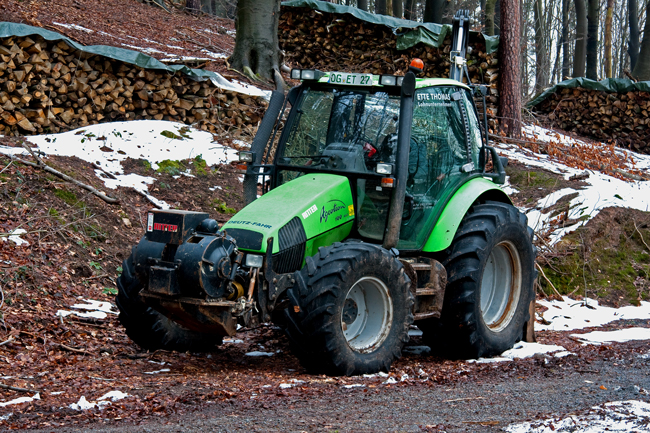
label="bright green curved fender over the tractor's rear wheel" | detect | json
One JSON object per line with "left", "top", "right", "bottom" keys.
{"left": 422, "top": 177, "right": 512, "bottom": 253}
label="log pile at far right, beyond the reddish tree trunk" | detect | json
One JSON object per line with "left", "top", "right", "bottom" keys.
{"left": 534, "top": 87, "right": 650, "bottom": 154}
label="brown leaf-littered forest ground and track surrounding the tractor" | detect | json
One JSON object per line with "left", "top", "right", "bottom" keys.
{"left": 0, "top": 0, "right": 650, "bottom": 432}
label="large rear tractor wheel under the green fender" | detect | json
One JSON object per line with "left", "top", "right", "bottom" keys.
{"left": 418, "top": 202, "right": 536, "bottom": 358}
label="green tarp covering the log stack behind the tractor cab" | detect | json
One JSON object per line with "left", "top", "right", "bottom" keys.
{"left": 282, "top": 0, "right": 499, "bottom": 54}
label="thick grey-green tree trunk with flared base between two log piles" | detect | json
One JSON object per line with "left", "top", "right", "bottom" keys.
{"left": 228, "top": 0, "right": 284, "bottom": 88}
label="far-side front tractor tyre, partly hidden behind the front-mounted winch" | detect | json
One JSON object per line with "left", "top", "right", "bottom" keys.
{"left": 115, "top": 251, "right": 223, "bottom": 352}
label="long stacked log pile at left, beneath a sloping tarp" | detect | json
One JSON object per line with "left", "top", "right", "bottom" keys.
{"left": 0, "top": 36, "right": 266, "bottom": 135}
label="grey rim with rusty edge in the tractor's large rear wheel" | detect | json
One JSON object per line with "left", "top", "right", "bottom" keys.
{"left": 480, "top": 241, "right": 521, "bottom": 332}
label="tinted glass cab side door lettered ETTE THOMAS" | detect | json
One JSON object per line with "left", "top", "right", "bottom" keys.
{"left": 397, "top": 86, "right": 481, "bottom": 250}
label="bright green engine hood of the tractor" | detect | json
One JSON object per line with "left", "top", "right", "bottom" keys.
{"left": 222, "top": 173, "right": 354, "bottom": 254}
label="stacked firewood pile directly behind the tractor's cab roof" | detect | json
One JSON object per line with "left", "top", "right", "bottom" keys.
{"left": 279, "top": 8, "right": 499, "bottom": 127}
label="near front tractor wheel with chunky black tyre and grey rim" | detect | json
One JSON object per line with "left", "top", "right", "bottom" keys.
{"left": 286, "top": 242, "right": 413, "bottom": 376}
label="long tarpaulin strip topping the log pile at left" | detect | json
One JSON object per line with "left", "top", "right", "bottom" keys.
{"left": 0, "top": 22, "right": 262, "bottom": 94}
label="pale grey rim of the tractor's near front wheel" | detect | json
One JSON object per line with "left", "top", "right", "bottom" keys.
{"left": 341, "top": 277, "right": 393, "bottom": 353}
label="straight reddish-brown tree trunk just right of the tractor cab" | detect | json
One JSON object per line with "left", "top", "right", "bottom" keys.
{"left": 499, "top": 0, "right": 521, "bottom": 138}
